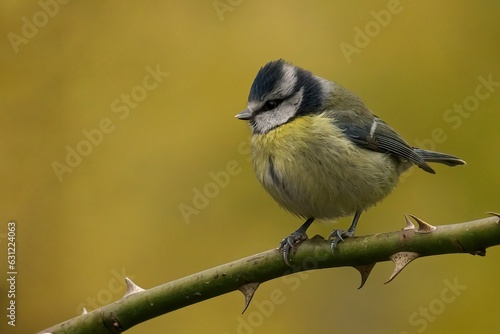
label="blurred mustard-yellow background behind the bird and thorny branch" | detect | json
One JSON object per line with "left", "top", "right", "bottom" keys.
{"left": 0, "top": 0, "right": 500, "bottom": 334}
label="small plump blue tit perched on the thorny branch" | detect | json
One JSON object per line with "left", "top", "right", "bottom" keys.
{"left": 236, "top": 59, "right": 465, "bottom": 265}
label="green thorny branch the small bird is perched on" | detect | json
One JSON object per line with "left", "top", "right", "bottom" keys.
{"left": 40, "top": 213, "right": 500, "bottom": 334}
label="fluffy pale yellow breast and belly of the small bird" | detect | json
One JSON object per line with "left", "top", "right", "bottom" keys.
{"left": 252, "top": 115, "right": 398, "bottom": 219}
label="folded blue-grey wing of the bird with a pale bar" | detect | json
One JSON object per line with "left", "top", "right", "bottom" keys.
{"left": 335, "top": 116, "right": 435, "bottom": 174}
